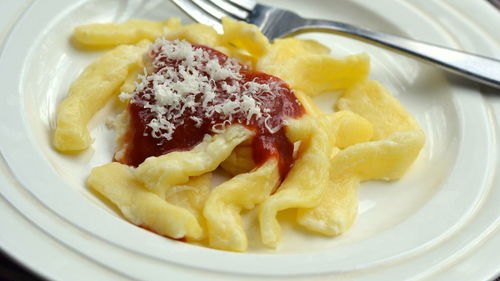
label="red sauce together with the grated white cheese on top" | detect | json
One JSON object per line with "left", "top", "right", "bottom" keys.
{"left": 115, "top": 39, "right": 304, "bottom": 176}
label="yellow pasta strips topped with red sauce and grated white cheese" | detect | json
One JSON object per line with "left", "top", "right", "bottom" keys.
{"left": 53, "top": 19, "right": 425, "bottom": 251}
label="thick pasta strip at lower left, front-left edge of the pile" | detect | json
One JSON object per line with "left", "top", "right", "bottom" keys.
{"left": 88, "top": 163, "right": 203, "bottom": 240}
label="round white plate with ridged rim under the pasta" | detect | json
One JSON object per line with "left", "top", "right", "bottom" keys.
{"left": 0, "top": 0, "right": 500, "bottom": 280}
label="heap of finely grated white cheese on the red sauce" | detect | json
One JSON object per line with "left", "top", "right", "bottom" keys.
{"left": 127, "top": 39, "right": 288, "bottom": 140}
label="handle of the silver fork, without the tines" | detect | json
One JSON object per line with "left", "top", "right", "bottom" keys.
{"left": 294, "top": 19, "right": 500, "bottom": 88}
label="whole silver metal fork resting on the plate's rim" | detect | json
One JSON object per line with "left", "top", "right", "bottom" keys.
{"left": 171, "top": 0, "right": 500, "bottom": 88}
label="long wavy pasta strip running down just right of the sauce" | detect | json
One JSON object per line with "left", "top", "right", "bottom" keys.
{"left": 259, "top": 116, "right": 333, "bottom": 247}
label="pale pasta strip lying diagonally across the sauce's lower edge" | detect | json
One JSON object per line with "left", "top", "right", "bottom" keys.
{"left": 135, "top": 125, "right": 254, "bottom": 197}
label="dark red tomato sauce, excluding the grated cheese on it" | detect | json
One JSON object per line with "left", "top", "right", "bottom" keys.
{"left": 120, "top": 42, "right": 305, "bottom": 178}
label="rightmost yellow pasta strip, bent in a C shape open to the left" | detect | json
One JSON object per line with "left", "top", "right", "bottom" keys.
{"left": 334, "top": 81, "right": 425, "bottom": 180}
